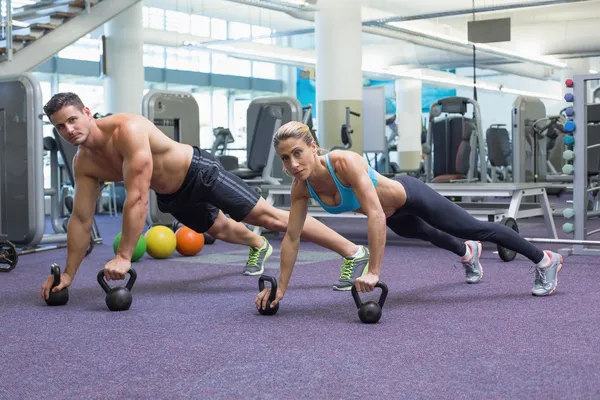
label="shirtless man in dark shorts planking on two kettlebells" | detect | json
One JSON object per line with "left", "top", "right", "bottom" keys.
{"left": 41, "top": 93, "right": 369, "bottom": 299}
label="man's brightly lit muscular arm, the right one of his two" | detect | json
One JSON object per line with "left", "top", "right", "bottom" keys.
{"left": 115, "top": 121, "right": 153, "bottom": 261}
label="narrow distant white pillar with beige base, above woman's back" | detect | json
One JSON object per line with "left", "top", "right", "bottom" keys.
{"left": 394, "top": 79, "right": 423, "bottom": 171}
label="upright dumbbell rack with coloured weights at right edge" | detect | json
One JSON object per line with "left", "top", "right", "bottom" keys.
{"left": 561, "top": 74, "right": 600, "bottom": 255}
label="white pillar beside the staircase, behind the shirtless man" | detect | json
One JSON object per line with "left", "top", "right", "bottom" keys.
{"left": 104, "top": 1, "right": 144, "bottom": 114}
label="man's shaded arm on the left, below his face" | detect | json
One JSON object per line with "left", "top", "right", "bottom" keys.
{"left": 64, "top": 156, "right": 100, "bottom": 279}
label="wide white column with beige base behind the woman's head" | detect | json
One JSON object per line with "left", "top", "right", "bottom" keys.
{"left": 315, "top": 0, "right": 363, "bottom": 155}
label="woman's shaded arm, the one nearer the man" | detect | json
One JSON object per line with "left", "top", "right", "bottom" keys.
{"left": 279, "top": 181, "right": 308, "bottom": 293}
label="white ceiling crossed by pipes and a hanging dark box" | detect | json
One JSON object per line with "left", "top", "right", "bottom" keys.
{"left": 144, "top": 0, "right": 600, "bottom": 78}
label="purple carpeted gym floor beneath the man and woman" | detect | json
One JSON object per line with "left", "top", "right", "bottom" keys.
{"left": 0, "top": 198, "right": 600, "bottom": 399}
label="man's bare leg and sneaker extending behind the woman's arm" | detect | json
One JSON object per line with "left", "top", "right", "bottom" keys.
{"left": 243, "top": 198, "right": 369, "bottom": 290}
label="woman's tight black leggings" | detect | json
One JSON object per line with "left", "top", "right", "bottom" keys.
{"left": 387, "top": 176, "right": 544, "bottom": 264}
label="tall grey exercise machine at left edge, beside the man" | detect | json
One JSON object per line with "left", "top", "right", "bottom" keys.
{"left": 0, "top": 73, "right": 102, "bottom": 269}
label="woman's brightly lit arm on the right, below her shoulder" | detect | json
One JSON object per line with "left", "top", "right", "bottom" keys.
{"left": 336, "top": 153, "right": 387, "bottom": 276}
